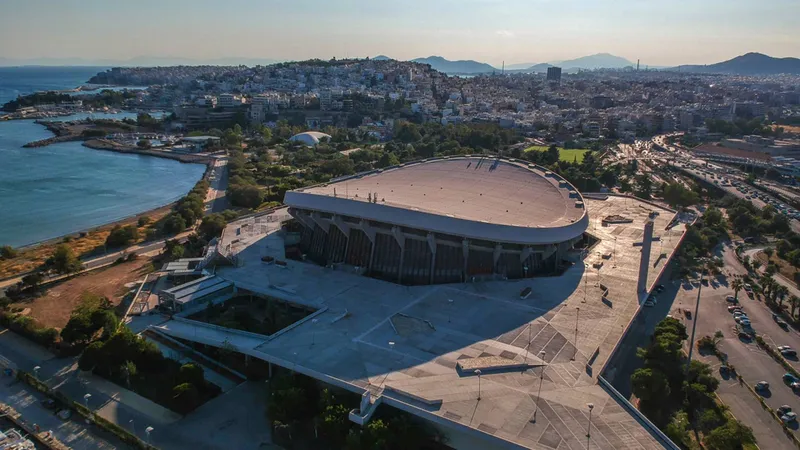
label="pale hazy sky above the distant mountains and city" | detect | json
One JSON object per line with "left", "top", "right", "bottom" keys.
{"left": 0, "top": 0, "right": 800, "bottom": 66}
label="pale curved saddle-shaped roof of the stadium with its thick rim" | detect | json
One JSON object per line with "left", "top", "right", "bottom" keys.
{"left": 285, "top": 156, "right": 588, "bottom": 244}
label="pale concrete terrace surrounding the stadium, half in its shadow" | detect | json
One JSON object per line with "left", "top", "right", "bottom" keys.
{"left": 157, "top": 197, "right": 685, "bottom": 450}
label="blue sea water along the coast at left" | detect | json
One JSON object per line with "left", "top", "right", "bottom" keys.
{"left": 0, "top": 67, "right": 205, "bottom": 247}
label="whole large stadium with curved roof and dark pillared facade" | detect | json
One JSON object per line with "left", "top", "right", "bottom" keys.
{"left": 285, "top": 156, "right": 589, "bottom": 285}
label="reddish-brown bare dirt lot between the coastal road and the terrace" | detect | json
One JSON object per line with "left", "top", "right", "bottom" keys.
{"left": 12, "top": 258, "right": 150, "bottom": 329}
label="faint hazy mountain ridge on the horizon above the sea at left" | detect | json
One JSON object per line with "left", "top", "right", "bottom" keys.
{"left": 0, "top": 56, "right": 281, "bottom": 67}
